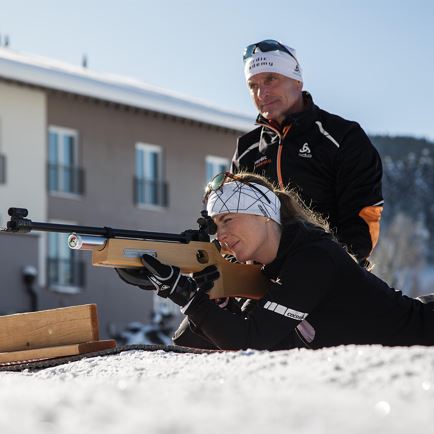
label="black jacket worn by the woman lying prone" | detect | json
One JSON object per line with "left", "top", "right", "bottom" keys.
{"left": 186, "top": 223, "right": 434, "bottom": 350}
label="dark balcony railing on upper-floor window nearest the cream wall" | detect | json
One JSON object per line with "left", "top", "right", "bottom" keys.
{"left": 47, "top": 163, "right": 84, "bottom": 194}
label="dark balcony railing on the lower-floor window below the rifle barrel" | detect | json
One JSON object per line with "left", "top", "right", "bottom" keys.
{"left": 47, "top": 258, "right": 85, "bottom": 289}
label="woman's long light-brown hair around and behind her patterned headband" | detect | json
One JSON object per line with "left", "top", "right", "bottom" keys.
{"left": 228, "top": 172, "right": 331, "bottom": 232}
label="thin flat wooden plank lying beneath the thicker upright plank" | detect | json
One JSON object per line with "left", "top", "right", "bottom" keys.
{"left": 0, "top": 339, "right": 116, "bottom": 363}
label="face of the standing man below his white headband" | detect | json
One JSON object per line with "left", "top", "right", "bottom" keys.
{"left": 247, "top": 72, "right": 303, "bottom": 124}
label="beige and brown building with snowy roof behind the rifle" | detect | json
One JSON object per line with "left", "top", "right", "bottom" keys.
{"left": 0, "top": 48, "right": 253, "bottom": 336}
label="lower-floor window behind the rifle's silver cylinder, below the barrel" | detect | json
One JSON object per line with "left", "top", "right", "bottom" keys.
{"left": 47, "top": 232, "right": 84, "bottom": 294}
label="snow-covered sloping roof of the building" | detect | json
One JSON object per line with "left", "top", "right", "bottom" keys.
{"left": 0, "top": 48, "right": 254, "bottom": 131}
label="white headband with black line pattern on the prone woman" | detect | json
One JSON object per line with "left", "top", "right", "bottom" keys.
{"left": 206, "top": 181, "right": 281, "bottom": 225}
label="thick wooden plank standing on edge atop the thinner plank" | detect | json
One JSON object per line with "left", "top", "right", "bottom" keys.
{"left": 0, "top": 304, "right": 99, "bottom": 352}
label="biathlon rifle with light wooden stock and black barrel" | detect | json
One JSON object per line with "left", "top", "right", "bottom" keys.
{"left": 4, "top": 208, "right": 269, "bottom": 299}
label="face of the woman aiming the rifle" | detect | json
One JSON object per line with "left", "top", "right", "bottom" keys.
{"left": 214, "top": 213, "right": 270, "bottom": 263}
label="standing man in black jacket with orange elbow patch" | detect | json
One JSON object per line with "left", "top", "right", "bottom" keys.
{"left": 231, "top": 40, "right": 383, "bottom": 266}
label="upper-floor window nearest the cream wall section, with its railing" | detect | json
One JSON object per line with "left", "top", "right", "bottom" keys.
{"left": 48, "top": 127, "right": 83, "bottom": 194}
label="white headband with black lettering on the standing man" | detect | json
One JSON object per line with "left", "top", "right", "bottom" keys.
{"left": 244, "top": 46, "right": 303, "bottom": 82}
